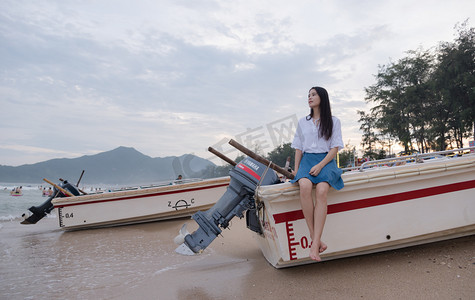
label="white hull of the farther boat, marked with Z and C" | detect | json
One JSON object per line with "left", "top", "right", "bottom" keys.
{"left": 52, "top": 177, "right": 229, "bottom": 230}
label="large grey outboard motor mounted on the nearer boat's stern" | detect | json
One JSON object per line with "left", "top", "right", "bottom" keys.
{"left": 175, "top": 157, "right": 280, "bottom": 254}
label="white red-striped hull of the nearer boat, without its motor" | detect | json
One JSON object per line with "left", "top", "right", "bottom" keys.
{"left": 257, "top": 155, "right": 475, "bottom": 268}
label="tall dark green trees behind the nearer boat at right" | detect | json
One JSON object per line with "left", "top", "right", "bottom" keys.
{"left": 357, "top": 21, "right": 475, "bottom": 158}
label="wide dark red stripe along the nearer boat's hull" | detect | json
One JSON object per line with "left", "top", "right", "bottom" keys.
{"left": 273, "top": 180, "right": 475, "bottom": 224}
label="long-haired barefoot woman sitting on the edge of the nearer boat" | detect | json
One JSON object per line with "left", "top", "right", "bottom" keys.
{"left": 291, "top": 87, "right": 344, "bottom": 261}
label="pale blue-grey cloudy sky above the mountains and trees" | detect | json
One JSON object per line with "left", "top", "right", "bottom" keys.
{"left": 0, "top": 0, "right": 475, "bottom": 166}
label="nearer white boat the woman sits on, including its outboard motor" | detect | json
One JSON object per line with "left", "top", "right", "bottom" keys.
{"left": 175, "top": 141, "right": 475, "bottom": 268}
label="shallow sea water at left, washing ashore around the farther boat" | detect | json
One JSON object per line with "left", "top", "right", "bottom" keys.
{"left": 0, "top": 184, "right": 210, "bottom": 299}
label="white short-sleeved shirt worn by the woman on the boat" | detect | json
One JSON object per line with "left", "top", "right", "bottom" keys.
{"left": 291, "top": 117, "right": 344, "bottom": 153}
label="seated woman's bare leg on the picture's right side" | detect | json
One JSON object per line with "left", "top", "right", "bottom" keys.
{"left": 307, "top": 182, "right": 330, "bottom": 261}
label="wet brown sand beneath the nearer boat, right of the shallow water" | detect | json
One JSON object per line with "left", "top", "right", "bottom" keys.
{"left": 118, "top": 220, "right": 475, "bottom": 299}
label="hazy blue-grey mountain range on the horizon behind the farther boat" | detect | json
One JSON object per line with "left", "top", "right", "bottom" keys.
{"left": 0, "top": 146, "right": 215, "bottom": 185}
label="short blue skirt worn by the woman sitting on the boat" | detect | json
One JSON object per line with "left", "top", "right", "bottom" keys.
{"left": 290, "top": 152, "right": 344, "bottom": 190}
